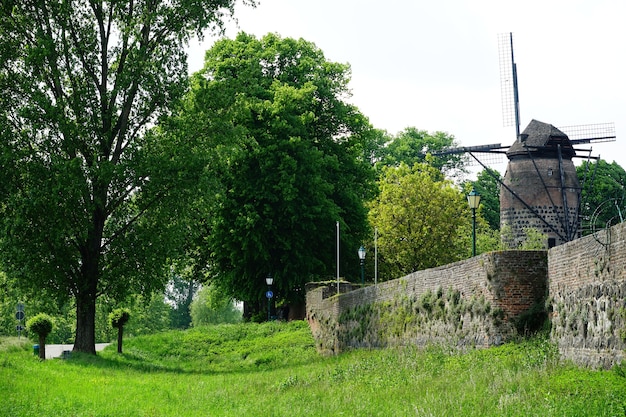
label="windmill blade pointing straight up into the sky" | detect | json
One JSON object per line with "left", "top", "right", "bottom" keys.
{"left": 498, "top": 32, "right": 520, "bottom": 138}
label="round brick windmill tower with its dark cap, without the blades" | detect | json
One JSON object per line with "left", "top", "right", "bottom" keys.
{"left": 500, "top": 120, "right": 581, "bottom": 247}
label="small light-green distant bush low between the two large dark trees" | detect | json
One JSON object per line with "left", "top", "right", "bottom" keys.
{"left": 191, "top": 284, "right": 241, "bottom": 327}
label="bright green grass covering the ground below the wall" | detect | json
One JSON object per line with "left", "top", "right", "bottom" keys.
{"left": 0, "top": 322, "right": 626, "bottom": 417}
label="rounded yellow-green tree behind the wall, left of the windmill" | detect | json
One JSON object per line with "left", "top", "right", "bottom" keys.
{"left": 370, "top": 163, "right": 470, "bottom": 278}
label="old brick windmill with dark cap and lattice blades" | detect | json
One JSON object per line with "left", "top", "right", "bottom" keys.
{"left": 434, "top": 33, "right": 615, "bottom": 247}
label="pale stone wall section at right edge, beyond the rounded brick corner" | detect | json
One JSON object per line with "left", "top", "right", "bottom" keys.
{"left": 548, "top": 223, "right": 626, "bottom": 368}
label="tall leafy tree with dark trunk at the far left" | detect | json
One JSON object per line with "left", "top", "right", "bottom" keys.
{"left": 0, "top": 0, "right": 246, "bottom": 354}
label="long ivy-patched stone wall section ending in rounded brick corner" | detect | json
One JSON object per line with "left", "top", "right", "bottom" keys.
{"left": 306, "top": 251, "right": 547, "bottom": 353}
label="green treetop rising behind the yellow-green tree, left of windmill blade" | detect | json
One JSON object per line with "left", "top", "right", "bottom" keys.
{"left": 377, "top": 127, "right": 467, "bottom": 178}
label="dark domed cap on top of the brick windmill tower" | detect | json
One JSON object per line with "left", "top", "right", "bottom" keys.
{"left": 506, "top": 119, "right": 576, "bottom": 159}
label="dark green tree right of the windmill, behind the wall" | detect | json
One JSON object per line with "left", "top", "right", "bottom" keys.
{"left": 576, "top": 159, "right": 626, "bottom": 234}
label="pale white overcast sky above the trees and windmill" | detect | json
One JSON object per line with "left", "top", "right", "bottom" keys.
{"left": 183, "top": 0, "right": 626, "bottom": 176}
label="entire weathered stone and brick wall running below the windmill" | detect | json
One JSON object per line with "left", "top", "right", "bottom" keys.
{"left": 307, "top": 224, "right": 626, "bottom": 367}
